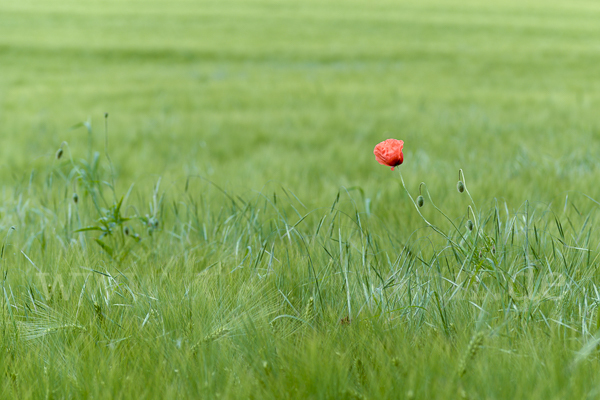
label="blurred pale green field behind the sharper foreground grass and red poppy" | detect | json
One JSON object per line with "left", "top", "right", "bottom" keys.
{"left": 0, "top": 0, "right": 600, "bottom": 212}
